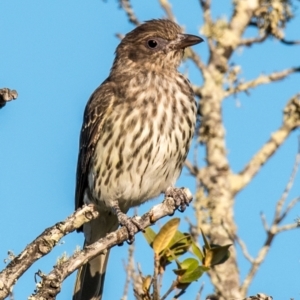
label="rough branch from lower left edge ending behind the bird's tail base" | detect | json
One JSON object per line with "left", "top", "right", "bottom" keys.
{"left": 0, "top": 205, "right": 98, "bottom": 299}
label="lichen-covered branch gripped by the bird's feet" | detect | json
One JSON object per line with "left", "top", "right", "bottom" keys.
{"left": 29, "top": 189, "right": 193, "bottom": 300}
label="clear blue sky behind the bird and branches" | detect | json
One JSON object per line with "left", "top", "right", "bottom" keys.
{"left": 0, "top": 0, "right": 300, "bottom": 300}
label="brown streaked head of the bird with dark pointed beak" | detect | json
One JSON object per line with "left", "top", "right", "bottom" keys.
{"left": 114, "top": 20, "right": 203, "bottom": 71}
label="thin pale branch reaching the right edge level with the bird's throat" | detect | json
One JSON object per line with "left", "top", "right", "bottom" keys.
{"left": 224, "top": 67, "right": 300, "bottom": 98}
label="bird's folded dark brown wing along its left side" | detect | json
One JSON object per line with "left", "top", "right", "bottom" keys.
{"left": 75, "top": 79, "right": 115, "bottom": 209}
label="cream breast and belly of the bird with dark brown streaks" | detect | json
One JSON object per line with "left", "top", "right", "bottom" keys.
{"left": 89, "top": 75, "right": 196, "bottom": 209}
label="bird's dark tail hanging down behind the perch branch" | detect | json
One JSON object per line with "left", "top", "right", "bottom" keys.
{"left": 73, "top": 212, "right": 118, "bottom": 300}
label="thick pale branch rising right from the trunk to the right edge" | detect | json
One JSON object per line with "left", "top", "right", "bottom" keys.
{"left": 231, "top": 95, "right": 300, "bottom": 193}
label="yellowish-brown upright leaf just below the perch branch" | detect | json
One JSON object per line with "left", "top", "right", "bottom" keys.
{"left": 153, "top": 218, "right": 180, "bottom": 254}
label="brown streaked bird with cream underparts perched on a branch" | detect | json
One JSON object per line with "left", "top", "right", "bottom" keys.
{"left": 73, "top": 19, "right": 203, "bottom": 300}
